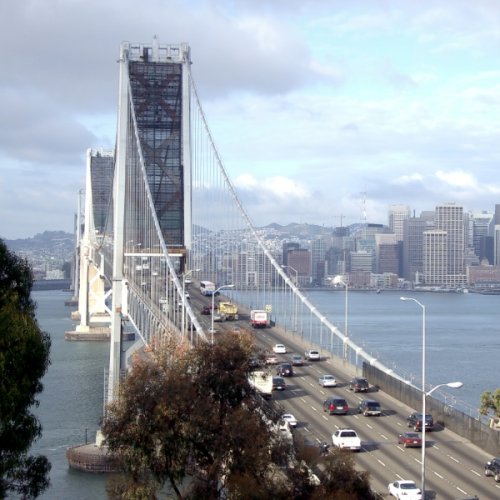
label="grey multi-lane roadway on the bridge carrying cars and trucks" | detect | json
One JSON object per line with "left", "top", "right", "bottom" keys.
{"left": 190, "top": 287, "right": 500, "bottom": 500}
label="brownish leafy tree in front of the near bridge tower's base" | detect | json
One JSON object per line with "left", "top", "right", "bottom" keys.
{"left": 102, "top": 333, "right": 316, "bottom": 499}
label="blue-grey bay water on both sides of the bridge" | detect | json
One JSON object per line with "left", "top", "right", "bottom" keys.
{"left": 32, "top": 290, "right": 500, "bottom": 500}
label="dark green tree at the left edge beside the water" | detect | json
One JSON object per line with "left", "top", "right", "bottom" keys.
{"left": 0, "top": 240, "right": 50, "bottom": 498}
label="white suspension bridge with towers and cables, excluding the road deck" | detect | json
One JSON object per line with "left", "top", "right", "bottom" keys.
{"left": 66, "top": 40, "right": 392, "bottom": 403}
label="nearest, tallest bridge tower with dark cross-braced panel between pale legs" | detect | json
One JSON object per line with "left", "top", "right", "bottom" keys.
{"left": 108, "top": 38, "right": 192, "bottom": 402}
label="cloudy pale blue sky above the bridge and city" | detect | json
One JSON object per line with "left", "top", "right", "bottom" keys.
{"left": 0, "top": 0, "right": 500, "bottom": 239}
